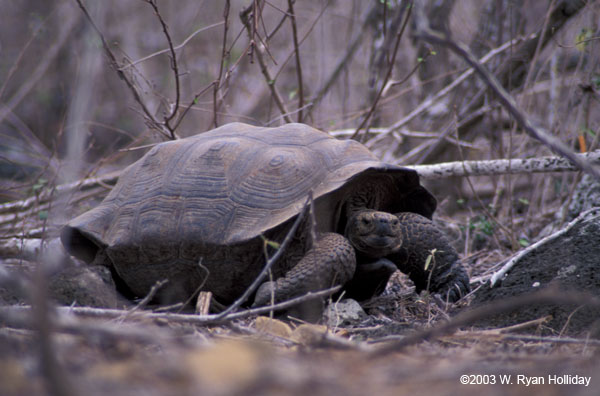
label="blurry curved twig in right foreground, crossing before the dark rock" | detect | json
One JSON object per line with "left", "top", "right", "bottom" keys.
{"left": 370, "top": 287, "right": 600, "bottom": 358}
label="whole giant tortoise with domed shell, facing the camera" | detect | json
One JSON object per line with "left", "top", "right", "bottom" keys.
{"left": 61, "top": 123, "right": 469, "bottom": 314}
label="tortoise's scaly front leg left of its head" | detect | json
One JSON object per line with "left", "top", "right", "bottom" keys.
{"left": 252, "top": 233, "right": 356, "bottom": 316}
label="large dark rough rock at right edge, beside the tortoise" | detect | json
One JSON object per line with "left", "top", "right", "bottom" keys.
{"left": 472, "top": 209, "right": 600, "bottom": 335}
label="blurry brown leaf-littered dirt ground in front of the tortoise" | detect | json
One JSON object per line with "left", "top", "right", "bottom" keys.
{"left": 0, "top": 272, "right": 600, "bottom": 396}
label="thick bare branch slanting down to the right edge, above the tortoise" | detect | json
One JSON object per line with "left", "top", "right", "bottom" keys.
{"left": 416, "top": 11, "right": 600, "bottom": 180}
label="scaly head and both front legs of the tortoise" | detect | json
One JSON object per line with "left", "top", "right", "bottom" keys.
{"left": 253, "top": 209, "right": 469, "bottom": 306}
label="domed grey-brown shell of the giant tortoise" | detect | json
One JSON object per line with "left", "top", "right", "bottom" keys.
{"left": 61, "top": 123, "right": 436, "bottom": 302}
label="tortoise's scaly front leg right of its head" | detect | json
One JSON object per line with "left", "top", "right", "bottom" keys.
{"left": 387, "top": 212, "right": 470, "bottom": 302}
